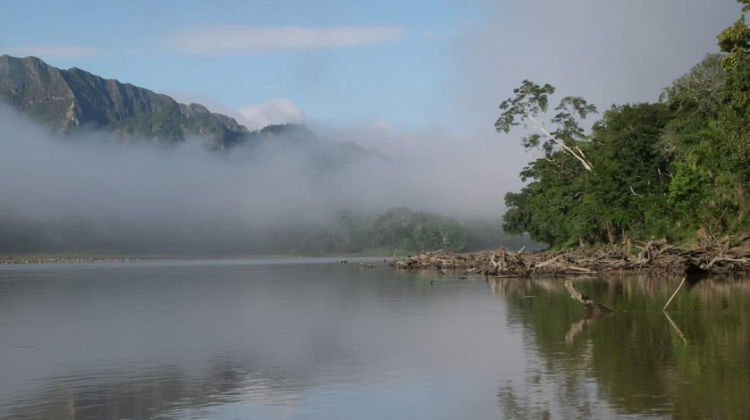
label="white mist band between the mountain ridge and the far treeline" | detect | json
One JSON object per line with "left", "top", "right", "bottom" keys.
{"left": 0, "top": 106, "right": 517, "bottom": 238}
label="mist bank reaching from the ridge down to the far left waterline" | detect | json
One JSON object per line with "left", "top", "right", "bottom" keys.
{"left": 0, "top": 107, "right": 528, "bottom": 253}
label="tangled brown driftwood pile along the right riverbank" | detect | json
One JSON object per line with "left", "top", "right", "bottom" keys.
{"left": 390, "top": 237, "right": 750, "bottom": 278}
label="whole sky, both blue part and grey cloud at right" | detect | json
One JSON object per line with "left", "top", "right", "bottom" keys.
{"left": 0, "top": 0, "right": 740, "bottom": 135}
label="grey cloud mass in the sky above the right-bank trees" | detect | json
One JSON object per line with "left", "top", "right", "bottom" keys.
{"left": 446, "top": 0, "right": 741, "bottom": 127}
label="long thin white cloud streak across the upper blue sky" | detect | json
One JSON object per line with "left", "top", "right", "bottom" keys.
{"left": 163, "top": 26, "right": 403, "bottom": 54}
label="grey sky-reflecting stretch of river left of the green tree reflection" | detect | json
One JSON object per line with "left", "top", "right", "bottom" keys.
{"left": 0, "top": 263, "right": 521, "bottom": 420}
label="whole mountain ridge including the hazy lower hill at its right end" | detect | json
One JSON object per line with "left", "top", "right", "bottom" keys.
{"left": 0, "top": 55, "right": 386, "bottom": 168}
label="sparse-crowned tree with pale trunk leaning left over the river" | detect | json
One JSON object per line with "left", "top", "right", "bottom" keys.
{"left": 495, "top": 80, "right": 597, "bottom": 171}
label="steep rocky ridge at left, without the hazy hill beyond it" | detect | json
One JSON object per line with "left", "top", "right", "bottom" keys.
{"left": 0, "top": 55, "right": 292, "bottom": 150}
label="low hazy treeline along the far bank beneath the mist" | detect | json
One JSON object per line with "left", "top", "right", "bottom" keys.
{"left": 0, "top": 208, "right": 539, "bottom": 256}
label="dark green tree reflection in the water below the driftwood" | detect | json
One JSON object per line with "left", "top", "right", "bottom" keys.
{"left": 490, "top": 277, "right": 750, "bottom": 419}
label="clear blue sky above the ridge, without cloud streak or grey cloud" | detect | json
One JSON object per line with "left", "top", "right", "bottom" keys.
{"left": 0, "top": 0, "right": 479, "bottom": 125}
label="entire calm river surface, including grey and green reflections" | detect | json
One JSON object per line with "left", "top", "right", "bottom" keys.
{"left": 0, "top": 259, "right": 750, "bottom": 420}
